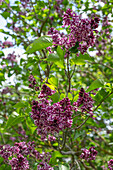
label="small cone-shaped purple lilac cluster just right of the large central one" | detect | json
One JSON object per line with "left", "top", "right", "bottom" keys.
{"left": 73, "top": 88, "right": 94, "bottom": 117}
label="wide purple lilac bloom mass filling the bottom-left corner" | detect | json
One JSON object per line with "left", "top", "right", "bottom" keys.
{"left": 0, "top": 142, "right": 52, "bottom": 170}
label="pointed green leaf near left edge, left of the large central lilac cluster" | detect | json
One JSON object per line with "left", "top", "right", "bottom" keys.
{"left": 5, "top": 112, "right": 25, "bottom": 129}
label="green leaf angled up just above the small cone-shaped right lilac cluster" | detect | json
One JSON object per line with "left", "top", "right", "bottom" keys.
{"left": 86, "top": 79, "right": 104, "bottom": 92}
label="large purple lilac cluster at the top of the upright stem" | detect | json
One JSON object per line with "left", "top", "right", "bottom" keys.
{"left": 48, "top": 9, "right": 100, "bottom": 54}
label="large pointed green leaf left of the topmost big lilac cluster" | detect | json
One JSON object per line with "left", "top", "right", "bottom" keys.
{"left": 25, "top": 36, "right": 52, "bottom": 54}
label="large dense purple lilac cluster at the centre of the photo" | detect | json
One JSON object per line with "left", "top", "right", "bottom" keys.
{"left": 31, "top": 85, "right": 73, "bottom": 140}
